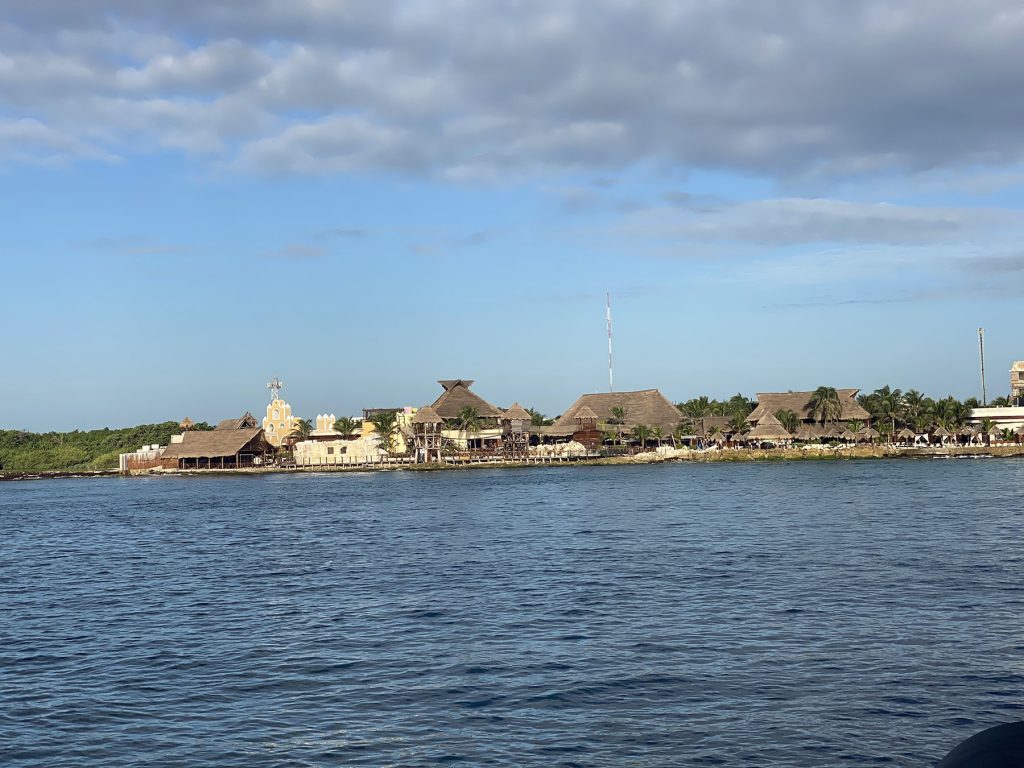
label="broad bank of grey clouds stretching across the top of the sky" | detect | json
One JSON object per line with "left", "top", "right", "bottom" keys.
{"left": 6, "top": 0, "right": 1024, "bottom": 177}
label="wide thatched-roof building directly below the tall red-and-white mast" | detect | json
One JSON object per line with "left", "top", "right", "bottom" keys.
{"left": 539, "top": 389, "right": 680, "bottom": 447}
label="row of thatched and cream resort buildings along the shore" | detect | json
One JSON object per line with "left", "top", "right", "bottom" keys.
{"left": 121, "top": 361, "right": 1024, "bottom": 472}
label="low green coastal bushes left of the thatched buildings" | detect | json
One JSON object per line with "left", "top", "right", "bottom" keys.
{"left": 0, "top": 421, "right": 212, "bottom": 472}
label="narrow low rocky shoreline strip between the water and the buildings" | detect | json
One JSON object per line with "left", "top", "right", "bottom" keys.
{"left": 6, "top": 445, "right": 1024, "bottom": 482}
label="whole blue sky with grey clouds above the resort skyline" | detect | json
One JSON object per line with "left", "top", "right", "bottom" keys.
{"left": 0, "top": 0, "right": 1024, "bottom": 429}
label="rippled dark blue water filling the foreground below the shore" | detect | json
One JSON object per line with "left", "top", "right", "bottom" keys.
{"left": 0, "top": 459, "right": 1024, "bottom": 768}
